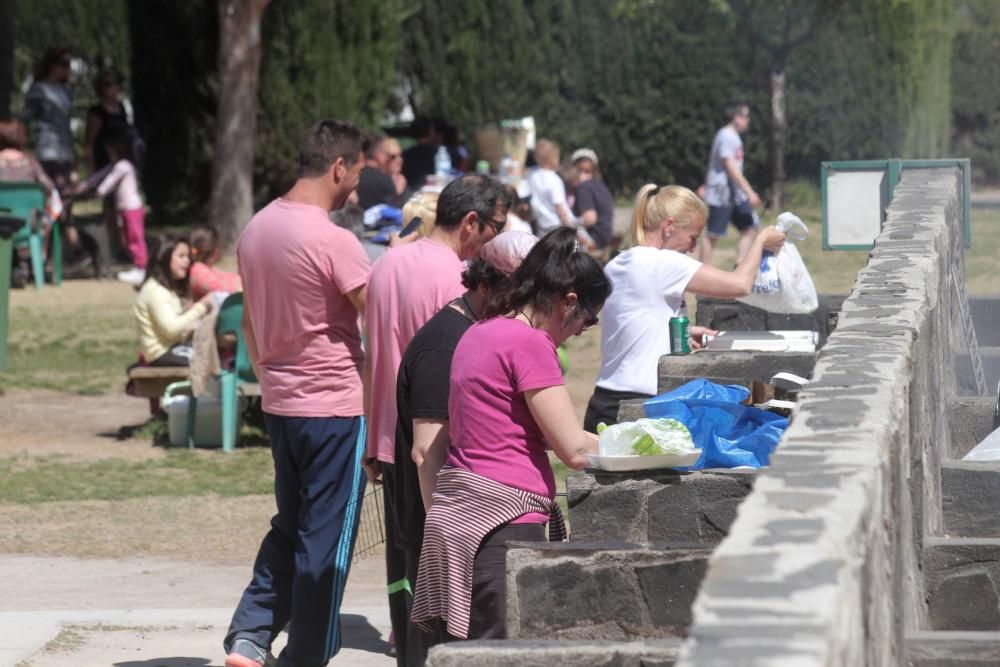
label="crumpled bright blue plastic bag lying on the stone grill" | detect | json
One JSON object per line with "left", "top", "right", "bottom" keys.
{"left": 642, "top": 379, "right": 788, "bottom": 470}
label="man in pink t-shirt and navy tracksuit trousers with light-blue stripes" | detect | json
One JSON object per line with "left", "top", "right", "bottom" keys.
{"left": 224, "top": 120, "right": 371, "bottom": 667}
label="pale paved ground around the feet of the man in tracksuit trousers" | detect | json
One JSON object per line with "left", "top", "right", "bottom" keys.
{"left": 0, "top": 556, "right": 395, "bottom": 667}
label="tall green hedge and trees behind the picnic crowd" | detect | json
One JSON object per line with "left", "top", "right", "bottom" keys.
{"left": 7, "top": 0, "right": 964, "bottom": 219}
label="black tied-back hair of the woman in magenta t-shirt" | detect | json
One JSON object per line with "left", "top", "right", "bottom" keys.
{"left": 485, "top": 227, "right": 611, "bottom": 317}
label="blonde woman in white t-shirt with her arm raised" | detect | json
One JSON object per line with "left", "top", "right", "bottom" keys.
{"left": 584, "top": 184, "right": 785, "bottom": 432}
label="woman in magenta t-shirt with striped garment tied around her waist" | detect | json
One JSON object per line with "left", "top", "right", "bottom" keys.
{"left": 412, "top": 227, "right": 611, "bottom": 639}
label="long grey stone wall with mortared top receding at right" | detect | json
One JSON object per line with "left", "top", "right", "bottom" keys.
{"left": 678, "top": 169, "right": 962, "bottom": 667}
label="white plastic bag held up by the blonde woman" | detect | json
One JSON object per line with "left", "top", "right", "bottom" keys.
{"left": 739, "top": 211, "right": 819, "bottom": 313}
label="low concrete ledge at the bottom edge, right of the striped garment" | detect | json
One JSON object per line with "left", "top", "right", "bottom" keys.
{"left": 427, "top": 639, "right": 680, "bottom": 667}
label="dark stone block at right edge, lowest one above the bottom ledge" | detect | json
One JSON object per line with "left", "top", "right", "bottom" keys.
{"left": 923, "top": 538, "right": 1000, "bottom": 631}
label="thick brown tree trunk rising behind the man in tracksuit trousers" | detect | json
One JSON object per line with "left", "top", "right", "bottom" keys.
{"left": 209, "top": 0, "right": 270, "bottom": 248}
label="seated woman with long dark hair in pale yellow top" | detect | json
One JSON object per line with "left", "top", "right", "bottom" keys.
{"left": 133, "top": 237, "right": 212, "bottom": 366}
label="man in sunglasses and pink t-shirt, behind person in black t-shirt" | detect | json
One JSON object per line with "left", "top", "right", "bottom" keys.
{"left": 365, "top": 174, "right": 510, "bottom": 664}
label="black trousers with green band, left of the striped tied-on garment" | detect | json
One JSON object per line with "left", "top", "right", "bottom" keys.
{"left": 380, "top": 463, "right": 446, "bottom": 667}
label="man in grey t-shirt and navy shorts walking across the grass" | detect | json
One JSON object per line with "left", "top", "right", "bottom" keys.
{"left": 700, "top": 101, "right": 760, "bottom": 264}
